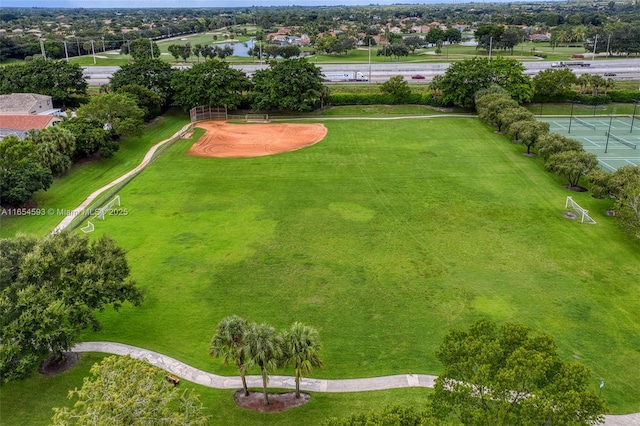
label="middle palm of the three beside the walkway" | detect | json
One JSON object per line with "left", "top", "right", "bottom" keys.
{"left": 244, "top": 323, "right": 283, "bottom": 405}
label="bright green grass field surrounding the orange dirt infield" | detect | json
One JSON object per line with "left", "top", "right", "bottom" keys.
{"left": 3, "top": 114, "right": 640, "bottom": 424}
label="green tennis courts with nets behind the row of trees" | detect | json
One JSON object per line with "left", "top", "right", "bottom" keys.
{"left": 538, "top": 115, "right": 640, "bottom": 171}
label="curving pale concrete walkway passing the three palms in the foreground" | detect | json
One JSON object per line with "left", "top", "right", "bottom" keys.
{"left": 71, "top": 342, "right": 640, "bottom": 426}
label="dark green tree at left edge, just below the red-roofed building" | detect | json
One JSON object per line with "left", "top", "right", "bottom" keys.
{"left": 0, "top": 135, "right": 53, "bottom": 207}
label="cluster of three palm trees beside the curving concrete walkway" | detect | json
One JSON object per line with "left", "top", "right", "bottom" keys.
{"left": 209, "top": 315, "right": 323, "bottom": 405}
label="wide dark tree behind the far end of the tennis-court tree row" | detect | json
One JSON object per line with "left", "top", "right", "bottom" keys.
{"left": 439, "top": 56, "right": 533, "bottom": 108}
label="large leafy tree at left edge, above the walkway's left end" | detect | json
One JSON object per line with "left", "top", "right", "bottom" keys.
{"left": 0, "top": 232, "right": 142, "bottom": 381}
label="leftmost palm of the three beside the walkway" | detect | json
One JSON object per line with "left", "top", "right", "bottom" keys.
{"left": 209, "top": 315, "right": 249, "bottom": 396}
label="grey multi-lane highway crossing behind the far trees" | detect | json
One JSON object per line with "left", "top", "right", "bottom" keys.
{"left": 84, "top": 59, "right": 640, "bottom": 86}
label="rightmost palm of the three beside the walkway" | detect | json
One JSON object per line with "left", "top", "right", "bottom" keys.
{"left": 284, "top": 322, "right": 323, "bottom": 398}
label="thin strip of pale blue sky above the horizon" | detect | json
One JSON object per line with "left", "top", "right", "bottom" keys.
{"left": 0, "top": 0, "right": 524, "bottom": 9}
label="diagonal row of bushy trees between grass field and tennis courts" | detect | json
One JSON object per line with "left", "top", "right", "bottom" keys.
{"left": 476, "top": 86, "right": 640, "bottom": 238}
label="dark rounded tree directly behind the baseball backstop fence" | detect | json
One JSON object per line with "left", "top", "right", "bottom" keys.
{"left": 171, "top": 59, "right": 251, "bottom": 111}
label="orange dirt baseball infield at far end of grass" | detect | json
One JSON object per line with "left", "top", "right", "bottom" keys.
{"left": 187, "top": 121, "right": 327, "bottom": 158}
